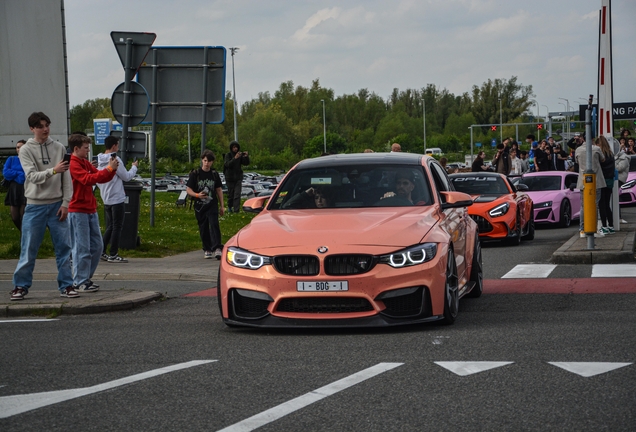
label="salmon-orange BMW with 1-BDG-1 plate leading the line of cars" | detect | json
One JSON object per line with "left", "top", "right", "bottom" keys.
{"left": 218, "top": 153, "right": 483, "bottom": 327}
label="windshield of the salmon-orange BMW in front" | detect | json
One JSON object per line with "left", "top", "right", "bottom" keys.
{"left": 269, "top": 164, "right": 432, "bottom": 210}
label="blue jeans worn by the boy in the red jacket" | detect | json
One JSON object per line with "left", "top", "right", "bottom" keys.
{"left": 68, "top": 212, "right": 104, "bottom": 286}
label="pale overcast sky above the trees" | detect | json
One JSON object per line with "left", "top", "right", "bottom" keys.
{"left": 64, "top": 0, "right": 636, "bottom": 116}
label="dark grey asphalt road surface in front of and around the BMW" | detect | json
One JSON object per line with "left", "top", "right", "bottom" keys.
{"left": 0, "top": 213, "right": 636, "bottom": 431}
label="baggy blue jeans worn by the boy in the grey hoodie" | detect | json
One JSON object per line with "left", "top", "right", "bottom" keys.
{"left": 13, "top": 201, "right": 73, "bottom": 292}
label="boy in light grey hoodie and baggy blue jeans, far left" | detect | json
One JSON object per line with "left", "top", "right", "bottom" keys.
{"left": 11, "top": 112, "right": 79, "bottom": 300}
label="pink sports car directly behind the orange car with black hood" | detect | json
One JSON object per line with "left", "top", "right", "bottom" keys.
{"left": 518, "top": 171, "right": 581, "bottom": 228}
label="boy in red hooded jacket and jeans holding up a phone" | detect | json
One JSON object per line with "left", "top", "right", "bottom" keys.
{"left": 68, "top": 134, "right": 119, "bottom": 292}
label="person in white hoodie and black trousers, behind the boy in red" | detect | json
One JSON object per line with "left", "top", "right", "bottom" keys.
{"left": 97, "top": 136, "right": 139, "bottom": 263}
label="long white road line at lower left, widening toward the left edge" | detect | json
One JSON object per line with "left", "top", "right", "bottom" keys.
{"left": 0, "top": 360, "right": 217, "bottom": 418}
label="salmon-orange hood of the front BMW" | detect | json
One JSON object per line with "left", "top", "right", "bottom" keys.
{"left": 236, "top": 206, "right": 438, "bottom": 255}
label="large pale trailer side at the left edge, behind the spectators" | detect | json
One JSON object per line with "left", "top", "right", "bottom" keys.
{"left": 0, "top": 0, "right": 70, "bottom": 155}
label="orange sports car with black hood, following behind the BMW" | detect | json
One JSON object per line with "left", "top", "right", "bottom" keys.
{"left": 450, "top": 172, "right": 534, "bottom": 245}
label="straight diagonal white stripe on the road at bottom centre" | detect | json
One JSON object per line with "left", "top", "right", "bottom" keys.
{"left": 219, "top": 363, "right": 404, "bottom": 432}
